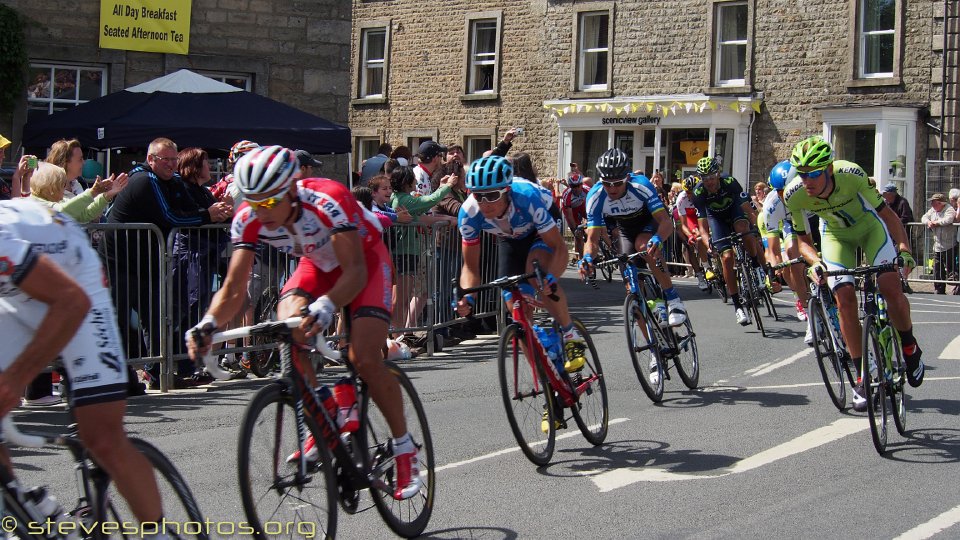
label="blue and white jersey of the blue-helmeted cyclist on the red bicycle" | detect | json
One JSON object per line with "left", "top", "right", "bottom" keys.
{"left": 457, "top": 178, "right": 557, "bottom": 245}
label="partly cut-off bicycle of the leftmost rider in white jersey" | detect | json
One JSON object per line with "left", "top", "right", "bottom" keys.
{"left": 0, "top": 415, "right": 210, "bottom": 540}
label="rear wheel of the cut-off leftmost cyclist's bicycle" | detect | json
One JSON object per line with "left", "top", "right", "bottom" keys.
{"left": 95, "top": 438, "right": 210, "bottom": 540}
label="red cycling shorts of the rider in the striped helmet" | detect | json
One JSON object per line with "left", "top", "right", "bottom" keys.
{"left": 280, "top": 242, "right": 393, "bottom": 323}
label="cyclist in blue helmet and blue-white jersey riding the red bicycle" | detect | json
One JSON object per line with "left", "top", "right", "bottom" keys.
{"left": 457, "top": 156, "right": 586, "bottom": 372}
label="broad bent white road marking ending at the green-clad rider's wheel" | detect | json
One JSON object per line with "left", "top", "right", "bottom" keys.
{"left": 585, "top": 418, "right": 870, "bottom": 493}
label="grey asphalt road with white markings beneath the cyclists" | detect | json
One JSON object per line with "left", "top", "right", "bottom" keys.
{"left": 14, "top": 275, "right": 960, "bottom": 539}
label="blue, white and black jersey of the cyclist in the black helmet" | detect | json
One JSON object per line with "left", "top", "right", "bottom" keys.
{"left": 587, "top": 175, "right": 664, "bottom": 227}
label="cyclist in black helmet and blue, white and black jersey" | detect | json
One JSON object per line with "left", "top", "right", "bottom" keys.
{"left": 580, "top": 148, "right": 687, "bottom": 326}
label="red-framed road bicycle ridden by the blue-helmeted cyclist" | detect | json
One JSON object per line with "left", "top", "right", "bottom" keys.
{"left": 454, "top": 262, "right": 610, "bottom": 466}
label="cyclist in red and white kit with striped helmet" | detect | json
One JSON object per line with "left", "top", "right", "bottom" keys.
{"left": 186, "top": 146, "right": 421, "bottom": 499}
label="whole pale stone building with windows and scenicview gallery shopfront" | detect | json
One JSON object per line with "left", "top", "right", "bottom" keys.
{"left": 350, "top": 0, "right": 960, "bottom": 206}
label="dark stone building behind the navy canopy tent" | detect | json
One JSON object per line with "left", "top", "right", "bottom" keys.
{"left": 0, "top": 0, "right": 351, "bottom": 179}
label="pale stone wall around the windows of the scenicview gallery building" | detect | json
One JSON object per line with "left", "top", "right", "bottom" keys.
{"left": 350, "top": 0, "right": 943, "bottom": 191}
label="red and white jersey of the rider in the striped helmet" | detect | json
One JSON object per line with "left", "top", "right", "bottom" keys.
{"left": 231, "top": 178, "right": 382, "bottom": 272}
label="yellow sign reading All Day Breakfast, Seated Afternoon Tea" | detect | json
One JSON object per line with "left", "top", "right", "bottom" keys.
{"left": 100, "top": 0, "right": 192, "bottom": 54}
